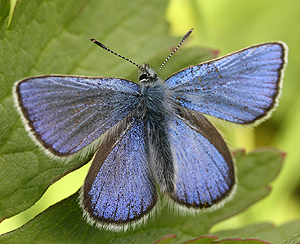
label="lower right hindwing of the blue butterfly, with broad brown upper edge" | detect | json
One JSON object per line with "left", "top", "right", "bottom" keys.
{"left": 169, "top": 108, "right": 235, "bottom": 208}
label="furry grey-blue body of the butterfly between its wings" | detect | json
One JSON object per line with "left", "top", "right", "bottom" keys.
{"left": 142, "top": 80, "right": 174, "bottom": 193}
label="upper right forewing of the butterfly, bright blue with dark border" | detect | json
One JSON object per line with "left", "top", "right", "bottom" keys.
{"left": 165, "top": 42, "right": 287, "bottom": 124}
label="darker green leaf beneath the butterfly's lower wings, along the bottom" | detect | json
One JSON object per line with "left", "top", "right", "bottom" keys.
{"left": 0, "top": 149, "right": 284, "bottom": 243}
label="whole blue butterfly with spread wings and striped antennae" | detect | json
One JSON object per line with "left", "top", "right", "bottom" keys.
{"left": 14, "top": 29, "right": 287, "bottom": 230}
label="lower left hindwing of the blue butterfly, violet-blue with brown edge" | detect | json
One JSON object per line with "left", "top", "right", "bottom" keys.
{"left": 81, "top": 115, "right": 157, "bottom": 228}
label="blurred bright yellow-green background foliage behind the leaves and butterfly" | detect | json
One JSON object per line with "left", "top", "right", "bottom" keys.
{"left": 0, "top": 0, "right": 300, "bottom": 240}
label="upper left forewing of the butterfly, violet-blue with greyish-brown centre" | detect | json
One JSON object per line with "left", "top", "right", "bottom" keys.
{"left": 15, "top": 76, "right": 140, "bottom": 156}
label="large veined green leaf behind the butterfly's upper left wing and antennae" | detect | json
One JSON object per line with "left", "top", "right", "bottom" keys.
{"left": 0, "top": 0, "right": 216, "bottom": 227}
